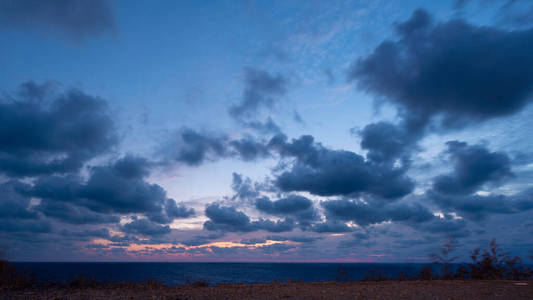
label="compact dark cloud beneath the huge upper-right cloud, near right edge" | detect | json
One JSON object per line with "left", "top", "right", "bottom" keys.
{"left": 433, "top": 141, "right": 513, "bottom": 195}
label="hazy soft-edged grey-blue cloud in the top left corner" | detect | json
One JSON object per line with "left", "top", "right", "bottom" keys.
{"left": 0, "top": 0, "right": 115, "bottom": 41}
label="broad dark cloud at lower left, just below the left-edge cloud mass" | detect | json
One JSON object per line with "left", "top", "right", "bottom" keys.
{"left": 26, "top": 155, "right": 194, "bottom": 224}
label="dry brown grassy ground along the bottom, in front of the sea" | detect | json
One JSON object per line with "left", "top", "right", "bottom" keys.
{"left": 0, "top": 280, "right": 533, "bottom": 300}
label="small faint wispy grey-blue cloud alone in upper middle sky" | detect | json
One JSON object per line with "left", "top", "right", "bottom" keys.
{"left": 229, "top": 68, "right": 287, "bottom": 120}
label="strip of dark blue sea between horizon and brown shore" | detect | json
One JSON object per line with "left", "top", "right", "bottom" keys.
{"left": 14, "top": 262, "right": 436, "bottom": 285}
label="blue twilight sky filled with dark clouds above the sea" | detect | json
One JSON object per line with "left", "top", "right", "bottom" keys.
{"left": 0, "top": 0, "right": 533, "bottom": 262}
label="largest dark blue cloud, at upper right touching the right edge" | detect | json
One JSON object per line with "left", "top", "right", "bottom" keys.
{"left": 348, "top": 10, "right": 533, "bottom": 128}
